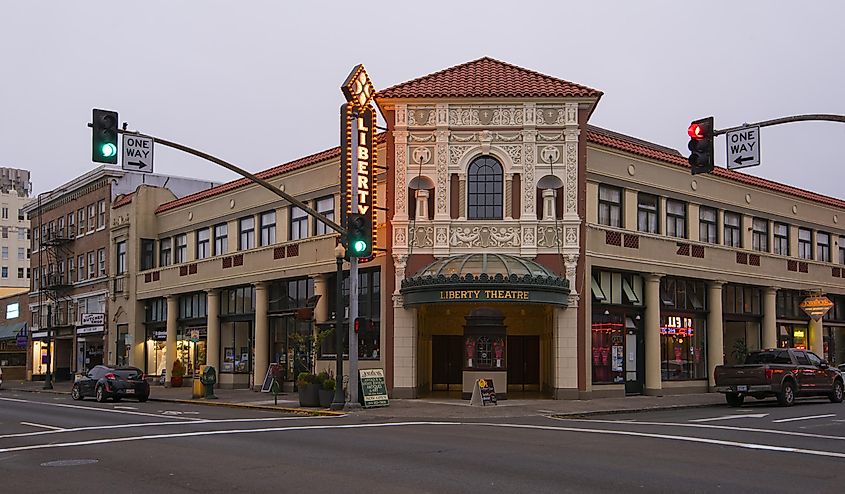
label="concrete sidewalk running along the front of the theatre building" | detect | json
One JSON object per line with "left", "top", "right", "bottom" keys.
{"left": 0, "top": 381, "right": 725, "bottom": 420}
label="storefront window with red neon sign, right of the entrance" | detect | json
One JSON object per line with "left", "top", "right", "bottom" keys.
{"left": 660, "top": 315, "right": 707, "bottom": 381}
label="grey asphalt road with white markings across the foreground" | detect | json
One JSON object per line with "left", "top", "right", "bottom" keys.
{"left": 0, "top": 392, "right": 845, "bottom": 493}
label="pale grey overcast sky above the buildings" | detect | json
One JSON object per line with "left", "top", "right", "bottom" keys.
{"left": 0, "top": 0, "right": 845, "bottom": 198}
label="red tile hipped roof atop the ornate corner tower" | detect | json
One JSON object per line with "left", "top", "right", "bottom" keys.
{"left": 376, "top": 57, "right": 602, "bottom": 98}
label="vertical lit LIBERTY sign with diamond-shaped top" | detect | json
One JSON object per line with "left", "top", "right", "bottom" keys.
{"left": 340, "top": 64, "right": 378, "bottom": 251}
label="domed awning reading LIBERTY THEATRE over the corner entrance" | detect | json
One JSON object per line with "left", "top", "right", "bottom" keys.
{"left": 400, "top": 253, "right": 569, "bottom": 307}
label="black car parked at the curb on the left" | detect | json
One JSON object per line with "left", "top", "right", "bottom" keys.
{"left": 70, "top": 365, "right": 150, "bottom": 403}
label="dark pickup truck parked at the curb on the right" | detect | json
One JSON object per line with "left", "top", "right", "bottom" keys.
{"left": 714, "top": 348, "right": 845, "bottom": 407}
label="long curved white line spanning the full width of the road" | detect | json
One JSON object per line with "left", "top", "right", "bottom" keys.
{"left": 0, "top": 422, "right": 845, "bottom": 458}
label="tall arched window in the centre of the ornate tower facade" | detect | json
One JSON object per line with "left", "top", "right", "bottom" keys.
{"left": 467, "top": 156, "right": 503, "bottom": 220}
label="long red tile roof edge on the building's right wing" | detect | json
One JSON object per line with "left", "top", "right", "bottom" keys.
{"left": 587, "top": 125, "right": 845, "bottom": 208}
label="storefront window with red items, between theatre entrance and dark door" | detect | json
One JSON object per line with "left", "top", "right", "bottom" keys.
{"left": 591, "top": 313, "right": 625, "bottom": 383}
